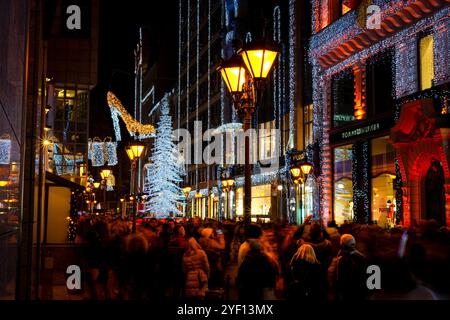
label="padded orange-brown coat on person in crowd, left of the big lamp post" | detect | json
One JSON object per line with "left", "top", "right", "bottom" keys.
{"left": 183, "top": 250, "right": 209, "bottom": 297}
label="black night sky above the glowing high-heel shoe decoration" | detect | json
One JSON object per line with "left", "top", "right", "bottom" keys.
{"left": 90, "top": 0, "right": 178, "bottom": 138}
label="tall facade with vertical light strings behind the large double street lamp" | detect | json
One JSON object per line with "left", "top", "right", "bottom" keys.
{"left": 174, "top": 0, "right": 314, "bottom": 221}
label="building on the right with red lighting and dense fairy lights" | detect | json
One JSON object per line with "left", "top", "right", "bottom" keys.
{"left": 309, "top": 0, "right": 450, "bottom": 226}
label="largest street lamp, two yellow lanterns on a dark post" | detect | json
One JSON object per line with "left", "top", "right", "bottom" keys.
{"left": 217, "top": 42, "right": 279, "bottom": 223}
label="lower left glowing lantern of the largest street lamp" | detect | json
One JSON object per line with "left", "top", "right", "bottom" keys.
{"left": 217, "top": 56, "right": 246, "bottom": 94}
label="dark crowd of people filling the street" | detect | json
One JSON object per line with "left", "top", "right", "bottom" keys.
{"left": 76, "top": 216, "right": 450, "bottom": 301}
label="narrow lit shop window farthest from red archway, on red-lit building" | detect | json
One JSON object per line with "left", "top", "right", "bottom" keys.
{"left": 334, "top": 144, "right": 354, "bottom": 225}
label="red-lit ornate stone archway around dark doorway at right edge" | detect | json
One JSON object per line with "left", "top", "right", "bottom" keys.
{"left": 391, "top": 100, "right": 450, "bottom": 226}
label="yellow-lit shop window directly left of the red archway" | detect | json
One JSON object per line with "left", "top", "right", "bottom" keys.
{"left": 371, "top": 137, "right": 396, "bottom": 227}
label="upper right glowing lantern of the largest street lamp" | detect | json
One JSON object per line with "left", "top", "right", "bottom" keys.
{"left": 238, "top": 42, "right": 278, "bottom": 80}
